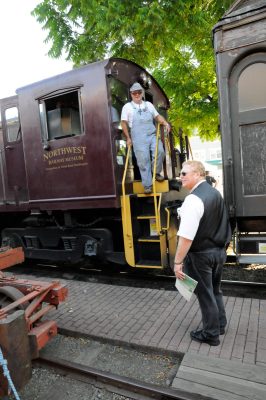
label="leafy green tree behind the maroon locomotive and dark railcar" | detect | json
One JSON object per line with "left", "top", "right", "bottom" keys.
{"left": 33, "top": 0, "right": 233, "bottom": 139}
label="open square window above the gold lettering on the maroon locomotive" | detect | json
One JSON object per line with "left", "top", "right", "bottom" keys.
{"left": 39, "top": 91, "right": 83, "bottom": 141}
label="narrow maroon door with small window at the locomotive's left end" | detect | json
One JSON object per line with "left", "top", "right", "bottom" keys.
{"left": 1, "top": 97, "right": 27, "bottom": 203}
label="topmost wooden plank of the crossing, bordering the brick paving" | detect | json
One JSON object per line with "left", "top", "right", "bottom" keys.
{"left": 181, "top": 353, "right": 266, "bottom": 384}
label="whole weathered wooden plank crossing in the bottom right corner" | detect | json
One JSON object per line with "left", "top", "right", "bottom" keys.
{"left": 172, "top": 353, "right": 266, "bottom": 400}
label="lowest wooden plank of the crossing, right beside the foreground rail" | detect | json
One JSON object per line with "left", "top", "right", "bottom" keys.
{"left": 172, "top": 378, "right": 245, "bottom": 400}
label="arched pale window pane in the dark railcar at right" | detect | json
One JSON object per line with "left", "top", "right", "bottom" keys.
{"left": 238, "top": 62, "right": 266, "bottom": 112}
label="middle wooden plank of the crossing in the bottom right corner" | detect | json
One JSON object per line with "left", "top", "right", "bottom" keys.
{"left": 177, "top": 364, "right": 266, "bottom": 400}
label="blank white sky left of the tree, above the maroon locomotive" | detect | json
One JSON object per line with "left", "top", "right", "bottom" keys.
{"left": 0, "top": 0, "right": 72, "bottom": 99}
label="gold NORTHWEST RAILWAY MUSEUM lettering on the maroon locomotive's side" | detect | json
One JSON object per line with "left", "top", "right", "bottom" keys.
{"left": 43, "top": 146, "right": 87, "bottom": 169}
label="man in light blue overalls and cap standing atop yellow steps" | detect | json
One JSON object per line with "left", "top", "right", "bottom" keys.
{"left": 121, "top": 82, "right": 170, "bottom": 194}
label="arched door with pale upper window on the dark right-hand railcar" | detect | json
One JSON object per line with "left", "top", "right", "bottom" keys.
{"left": 230, "top": 53, "right": 266, "bottom": 217}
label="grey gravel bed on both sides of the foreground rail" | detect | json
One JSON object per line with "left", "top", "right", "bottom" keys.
{"left": 14, "top": 335, "right": 181, "bottom": 400}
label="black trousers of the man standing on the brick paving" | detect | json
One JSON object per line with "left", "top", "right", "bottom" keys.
{"left": 184, "top": 248, "right": 227, "bottom": 337}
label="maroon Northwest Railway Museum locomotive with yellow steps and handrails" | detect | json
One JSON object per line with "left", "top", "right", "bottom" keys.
{"left": 0, "top": 58, "right": 183, "bottom": 269}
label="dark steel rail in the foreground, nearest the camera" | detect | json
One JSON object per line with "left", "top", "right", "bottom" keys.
{"left": 33, "top": 356, "right": 211, "bottom": 400}
